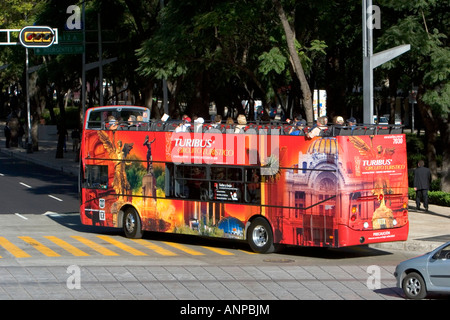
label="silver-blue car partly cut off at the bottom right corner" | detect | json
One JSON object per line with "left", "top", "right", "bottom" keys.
{"left": 394, "top": 241, "right": 450, "bottom": 299}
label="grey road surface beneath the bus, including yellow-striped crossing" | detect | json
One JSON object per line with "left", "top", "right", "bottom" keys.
{"left": 0, "top": 155, "right": 434, "bottom": 302}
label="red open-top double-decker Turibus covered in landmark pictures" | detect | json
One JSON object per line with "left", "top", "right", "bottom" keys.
{"left": 80, "top": 106, "right": 409, "bottom": 252}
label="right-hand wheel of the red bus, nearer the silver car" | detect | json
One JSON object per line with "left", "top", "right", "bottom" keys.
{"left": 247, "top": 217, "right": 275, "bottom": 253}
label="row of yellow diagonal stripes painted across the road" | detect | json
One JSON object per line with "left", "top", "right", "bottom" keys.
{"left": 0, "top": 235, "right": 248, "bottom": 259}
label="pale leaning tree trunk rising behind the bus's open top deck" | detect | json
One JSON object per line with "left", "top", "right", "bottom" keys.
{"left": 272, "top": 0, "right": 314, "bottom": 124}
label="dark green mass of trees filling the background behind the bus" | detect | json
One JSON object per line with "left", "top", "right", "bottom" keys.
{"left": 0, "top": 0, "right": 450, "bottom": 192}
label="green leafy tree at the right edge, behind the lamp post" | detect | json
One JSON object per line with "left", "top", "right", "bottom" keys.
{"left": 379, "top": 0, "right": 450, "bottom": 192}
